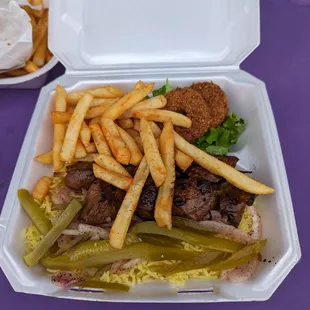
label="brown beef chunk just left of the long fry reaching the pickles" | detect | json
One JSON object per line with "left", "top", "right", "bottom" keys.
{"left": 80, "top": 180, "right": 125, "bottom": 225}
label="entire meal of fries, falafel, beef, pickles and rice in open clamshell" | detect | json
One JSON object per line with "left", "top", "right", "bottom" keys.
{"left": 18, "top": 80, "right": 274, "bottom": 291}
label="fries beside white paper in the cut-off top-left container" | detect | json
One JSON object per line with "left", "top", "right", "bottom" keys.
{"left": 0, "top": 0, "right": 53, "bottom": 78}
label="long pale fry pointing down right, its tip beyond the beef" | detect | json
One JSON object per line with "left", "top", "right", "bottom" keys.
{"left": 174, "top": 132, "right": 274, "bottom": 195}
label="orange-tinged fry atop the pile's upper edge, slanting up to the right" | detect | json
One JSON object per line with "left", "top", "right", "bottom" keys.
{"left": 103, "top": 83, "right": 154, "bottom": 120}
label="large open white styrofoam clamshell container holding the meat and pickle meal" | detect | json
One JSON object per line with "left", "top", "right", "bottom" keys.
{"left": 0, "top": 0, "right": 301, "bottom": 302}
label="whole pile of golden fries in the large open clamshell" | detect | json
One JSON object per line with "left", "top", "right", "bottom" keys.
{"left": 36, "top": 81, "right": 273, "bottom": 248}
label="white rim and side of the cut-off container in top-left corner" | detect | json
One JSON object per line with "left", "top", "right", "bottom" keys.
{"left": 0, "top": 0, "right": 58, "bottom": 89}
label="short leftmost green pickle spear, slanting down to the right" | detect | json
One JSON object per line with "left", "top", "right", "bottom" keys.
{"left": 17, "top": 189, "right": 52, "bottom": 236}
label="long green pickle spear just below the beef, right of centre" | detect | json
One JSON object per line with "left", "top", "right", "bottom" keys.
{"left": 131, "top": 222, "right": 244, "bottom": 253}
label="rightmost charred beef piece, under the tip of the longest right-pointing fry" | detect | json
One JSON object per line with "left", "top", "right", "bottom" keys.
{"left": 218, "top": 182, "right": 256, "bottom": 227}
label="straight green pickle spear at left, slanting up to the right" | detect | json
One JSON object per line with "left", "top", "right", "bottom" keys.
{"left": 24, "top": 199, "right": 82, "bottom": 266}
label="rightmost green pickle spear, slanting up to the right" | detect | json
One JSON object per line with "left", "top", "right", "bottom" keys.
{"left": 209, "top": 240, "right": 267, "bottom": 271}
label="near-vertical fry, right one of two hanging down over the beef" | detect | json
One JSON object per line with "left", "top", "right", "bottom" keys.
{"left": 154, "top": 121, "right": 175, "bottom": 229}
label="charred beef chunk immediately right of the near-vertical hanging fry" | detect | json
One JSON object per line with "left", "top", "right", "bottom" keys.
{"left": 172, "top": 177, "right": 216, "bottom": 221}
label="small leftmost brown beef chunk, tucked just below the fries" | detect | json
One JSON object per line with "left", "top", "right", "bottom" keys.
{"left": 65, "top": 162, "right": 95, "bottom": 189}
